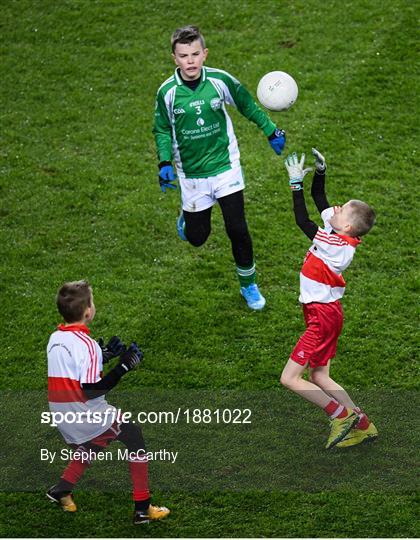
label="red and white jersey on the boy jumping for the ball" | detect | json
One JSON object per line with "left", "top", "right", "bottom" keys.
{"left": 299, "top": 207, "right": 361, "bottom": 304}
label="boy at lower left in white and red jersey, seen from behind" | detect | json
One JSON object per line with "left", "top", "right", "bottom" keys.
{"left": 47, "top": 281, "right": 169, "bottom": 525}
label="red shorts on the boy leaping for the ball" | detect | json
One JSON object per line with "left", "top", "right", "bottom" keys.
{"left": 290, "top": 300, "right": 344, "bottom": 368}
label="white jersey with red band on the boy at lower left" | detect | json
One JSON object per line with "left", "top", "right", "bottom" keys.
{"left": 47, "top": 324, "right": 116, "bottom": 444}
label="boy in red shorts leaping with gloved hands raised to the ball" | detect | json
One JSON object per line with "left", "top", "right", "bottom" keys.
{"left": 280, "top": 148, "right": 378, "bottom": 448}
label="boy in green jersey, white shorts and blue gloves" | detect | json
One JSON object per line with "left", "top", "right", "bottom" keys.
{"left": 153, "top": 26, "right": 286, "bottom": 309}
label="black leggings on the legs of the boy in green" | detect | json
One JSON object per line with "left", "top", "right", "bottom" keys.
{"left": 183, "top": 190, "right": 254, "bottom": 268}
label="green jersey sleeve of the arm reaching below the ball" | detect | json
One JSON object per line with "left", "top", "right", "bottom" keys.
{"left": 220, "top": 73, "right": 276, "bottom": 137}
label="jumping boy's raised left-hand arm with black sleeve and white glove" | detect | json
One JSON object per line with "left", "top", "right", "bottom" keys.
{"left": 285, "top": 152, "right": 318, "bottom": 240}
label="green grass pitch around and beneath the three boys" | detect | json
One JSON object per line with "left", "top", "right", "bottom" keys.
{"left": 0, "top": 0, "right": 420, "bottom": 537}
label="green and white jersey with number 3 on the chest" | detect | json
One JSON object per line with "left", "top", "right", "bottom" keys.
{"left": 153, "top": 67, "right": 276, "bottom": 178}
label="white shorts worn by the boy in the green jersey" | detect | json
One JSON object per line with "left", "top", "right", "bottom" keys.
{"left": 179, "top": 167, "right": 245, "bottom": 212}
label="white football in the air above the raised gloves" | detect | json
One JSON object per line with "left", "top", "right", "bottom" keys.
{"left": 257, "top": 71, "right": 298, "bottom": 111}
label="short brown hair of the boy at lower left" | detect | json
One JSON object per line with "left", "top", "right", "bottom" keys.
{"left": 57, "top": 279, "right": 92, "bottom": 323}
